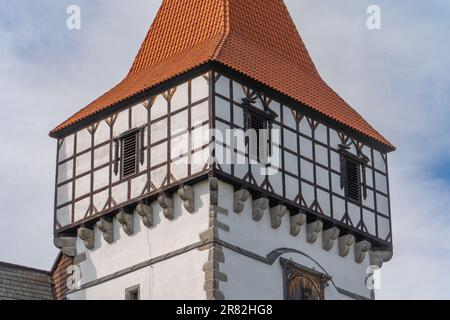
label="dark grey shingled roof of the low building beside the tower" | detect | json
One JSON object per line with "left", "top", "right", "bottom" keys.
{"left": 0, "top": 262, "right": 53, "bottom": 300}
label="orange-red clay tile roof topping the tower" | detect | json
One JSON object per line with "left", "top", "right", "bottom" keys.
{"left": 50, "top": 0, "right": 394, "bottom": 149}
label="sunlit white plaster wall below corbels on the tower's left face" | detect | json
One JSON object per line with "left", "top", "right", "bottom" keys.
{"left": 73, "top": 181, "right": 209, "bottom": 299}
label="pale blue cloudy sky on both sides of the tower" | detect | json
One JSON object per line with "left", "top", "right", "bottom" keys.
{"left": 0, "top": 0, "right": 450, "bottom": 299}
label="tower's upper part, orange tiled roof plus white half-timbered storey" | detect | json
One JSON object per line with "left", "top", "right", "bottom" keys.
{"left": 50, "top": 0, "right": 394, "bottom": 247}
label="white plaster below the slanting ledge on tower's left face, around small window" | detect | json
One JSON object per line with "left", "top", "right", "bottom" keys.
{"left": 69, "top": 249, "right": 208, "bottom": 300}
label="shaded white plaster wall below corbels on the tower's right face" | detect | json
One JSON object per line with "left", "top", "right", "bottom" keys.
{"left": 218, "top": 182, "right": 370, "bottom": 299}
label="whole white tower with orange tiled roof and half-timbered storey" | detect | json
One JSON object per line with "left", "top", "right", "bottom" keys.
{"left": 50, "top": 0, "right": 395, "bottom": 299}
